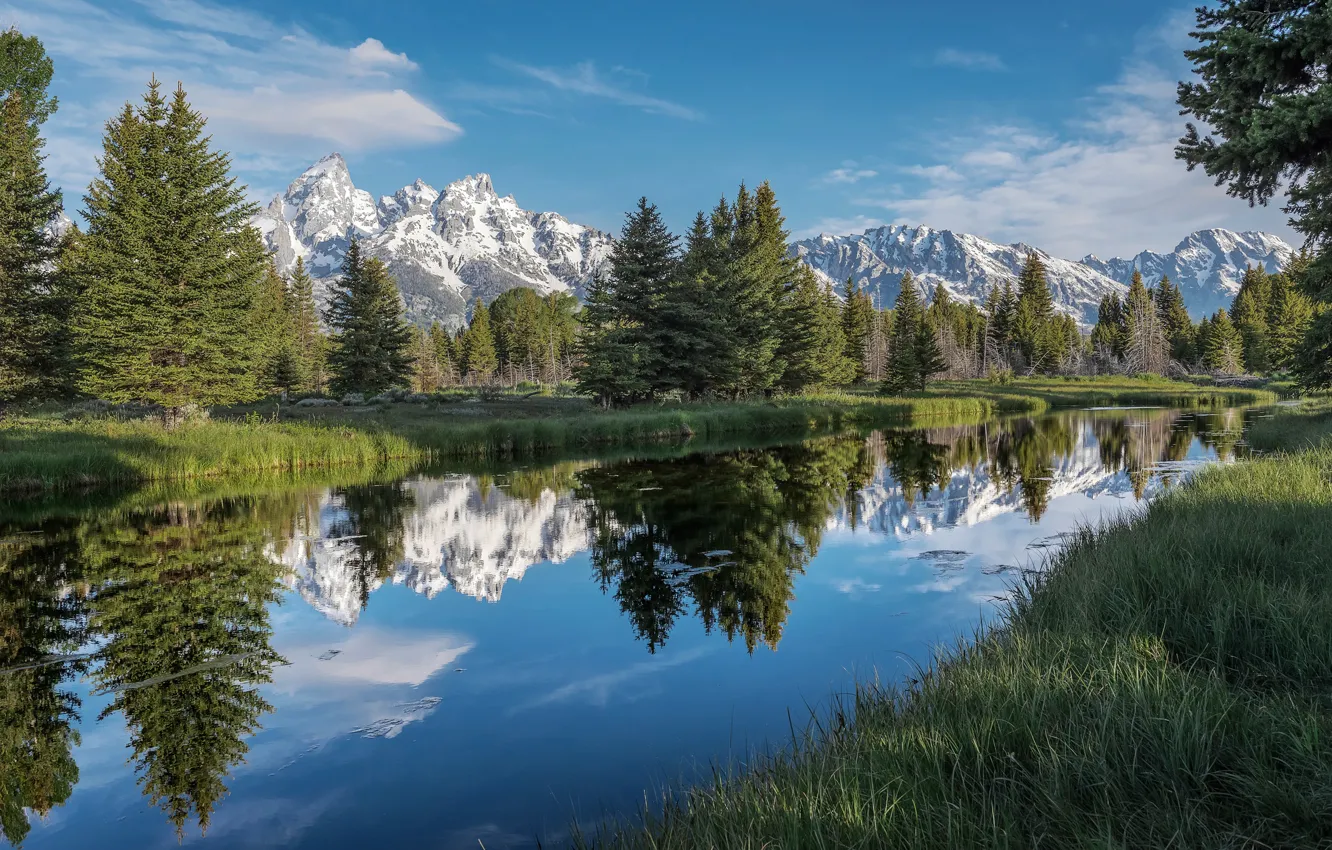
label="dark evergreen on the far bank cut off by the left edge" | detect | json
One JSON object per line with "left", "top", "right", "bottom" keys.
{"left": 0, "top": 83, "right": 69, "bottom": 402}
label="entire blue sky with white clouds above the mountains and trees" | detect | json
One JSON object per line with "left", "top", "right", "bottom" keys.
{"left": 10, "top": 0, "right": 1299, "bottom": 258}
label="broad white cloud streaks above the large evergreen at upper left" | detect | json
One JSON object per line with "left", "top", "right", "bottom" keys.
{"left": 11, "top": 0, "right": 462, "bottom": 198}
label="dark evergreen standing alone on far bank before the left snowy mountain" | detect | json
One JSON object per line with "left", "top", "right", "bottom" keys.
{"left": 325, "top": 238, "right": 412, "bottom": 396}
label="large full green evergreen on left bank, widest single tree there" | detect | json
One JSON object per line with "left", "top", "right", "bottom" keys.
{"left": 77, "top": 80, "right": 268, "bottom": 418}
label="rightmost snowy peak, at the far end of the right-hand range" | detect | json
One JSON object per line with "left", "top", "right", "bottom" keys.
{"left": 1083, "top": 230, "right": 1295, "bottom": 318}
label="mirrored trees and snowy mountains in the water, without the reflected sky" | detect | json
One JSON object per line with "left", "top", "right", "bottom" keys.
{"left": 0, "top": 410, "right": 1244, "bottom": 845}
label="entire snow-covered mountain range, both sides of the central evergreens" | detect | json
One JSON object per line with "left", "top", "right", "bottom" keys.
{"left": 242, "top": 153, "right": 1295, "bottom": 328}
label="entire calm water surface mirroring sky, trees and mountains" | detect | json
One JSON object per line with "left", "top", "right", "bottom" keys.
{"left": 0, "top": 409, "right": 1252, "bottom": 850}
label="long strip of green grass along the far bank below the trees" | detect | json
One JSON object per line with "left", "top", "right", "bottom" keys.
{"left": 0, "top": 378, "right": 1276, "bottom": 493}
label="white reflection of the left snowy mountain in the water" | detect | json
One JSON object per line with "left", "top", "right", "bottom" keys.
{"left": 269, "top": 476, "right": 587, "bottom": 626}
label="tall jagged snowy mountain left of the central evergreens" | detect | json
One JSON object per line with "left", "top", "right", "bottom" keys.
{"left": 254, "top": 153, "right": 613, "bottom": 326}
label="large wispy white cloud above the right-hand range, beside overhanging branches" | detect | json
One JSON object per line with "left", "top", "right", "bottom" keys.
{"left": 862, "top": 9, "right": 1296, "bottom": 257}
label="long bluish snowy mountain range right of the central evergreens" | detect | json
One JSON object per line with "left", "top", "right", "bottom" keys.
{"left": 791, "top": 225, "right": 1293, "bottom": 325}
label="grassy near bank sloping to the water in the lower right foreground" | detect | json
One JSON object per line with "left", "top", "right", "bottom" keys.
{"left": 589, "top": 402, "right": 1332, "bottom": 850}
